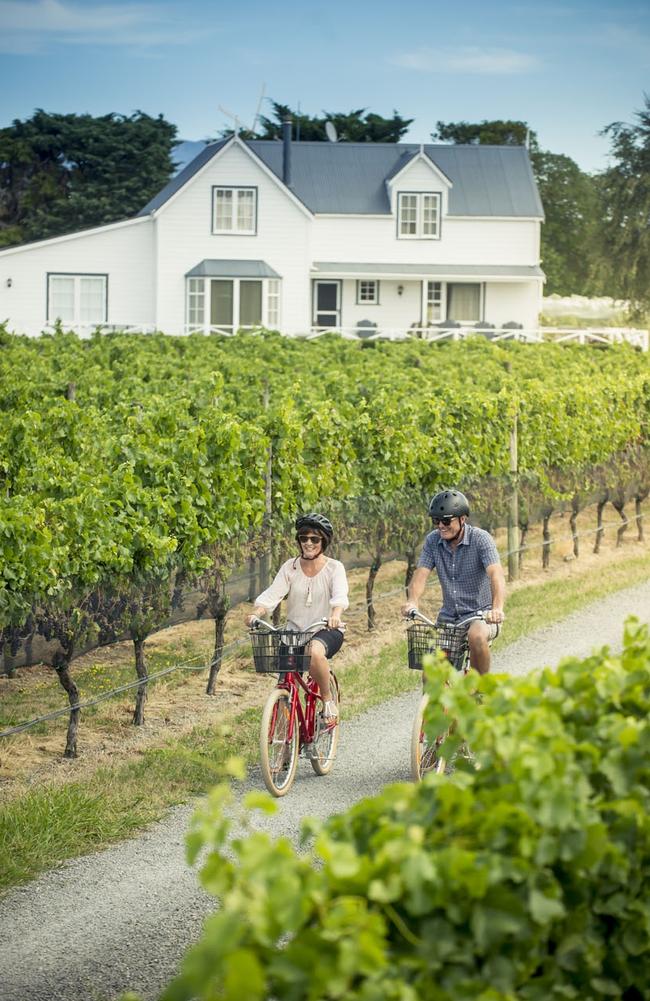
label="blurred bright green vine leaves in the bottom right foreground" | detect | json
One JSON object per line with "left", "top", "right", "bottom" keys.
{"left": 157, "top": 621, "right": 650, "bottom": 1001}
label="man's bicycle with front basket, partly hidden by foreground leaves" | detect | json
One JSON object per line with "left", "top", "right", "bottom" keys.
{"left": 406, "top": 609, "right": 485, "bottom": 782}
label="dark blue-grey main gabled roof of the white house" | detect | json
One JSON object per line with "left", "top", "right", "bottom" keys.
{"left": 140, "top": 139, "right": 544, "bottom": 218}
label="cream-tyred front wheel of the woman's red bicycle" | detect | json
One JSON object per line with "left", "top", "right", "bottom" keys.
{"left": 259, "top": 689, "right": 298, "bottom": 797}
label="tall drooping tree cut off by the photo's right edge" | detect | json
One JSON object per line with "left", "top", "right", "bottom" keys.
{"left": 599, "top": 94, "right": 650, "bottom": 313}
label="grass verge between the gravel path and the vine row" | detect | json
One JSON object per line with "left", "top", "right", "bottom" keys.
{"left": 0, "top": 556, "right": 650, "bottom": 889}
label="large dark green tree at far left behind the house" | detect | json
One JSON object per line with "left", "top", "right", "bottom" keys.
{"left": 0, "top": 109, "right": 176, "bottom": 246}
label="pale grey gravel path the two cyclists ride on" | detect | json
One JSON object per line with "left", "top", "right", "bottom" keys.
{"left": 0, "top": 582, "right": 650, "bottom": 1001}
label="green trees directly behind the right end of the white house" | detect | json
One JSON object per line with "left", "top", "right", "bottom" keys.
{"left": 432, "top": 120, "right": 601, "bottom": 295}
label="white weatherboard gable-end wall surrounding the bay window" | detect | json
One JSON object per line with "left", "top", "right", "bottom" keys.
{"left": 156, "top": 143, "right": 311, "bottom": 333}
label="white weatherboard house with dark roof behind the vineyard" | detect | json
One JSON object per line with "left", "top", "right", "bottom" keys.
{"left": 0, "top": 123, "right": 544, "bottom": 334}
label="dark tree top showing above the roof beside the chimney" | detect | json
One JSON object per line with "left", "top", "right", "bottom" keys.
{"left": 221, "top": 101, "right": 414, "bottom": 142}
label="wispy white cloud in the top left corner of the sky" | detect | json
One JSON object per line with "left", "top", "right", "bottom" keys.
{"left": 0, "top": 0, "right": 210, "bottom": 54}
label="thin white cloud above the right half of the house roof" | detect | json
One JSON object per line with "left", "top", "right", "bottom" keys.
{"left": 391, "top": 45, "right": 540, "bottom": 76}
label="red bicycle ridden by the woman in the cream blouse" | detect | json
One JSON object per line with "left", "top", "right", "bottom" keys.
{"left": 249, "top": 619, "right": 341, "bottom": 797}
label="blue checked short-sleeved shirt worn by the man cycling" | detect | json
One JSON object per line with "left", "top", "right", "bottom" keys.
{"left": 418, "top": 522, "right": 501, "bottom": 623}
